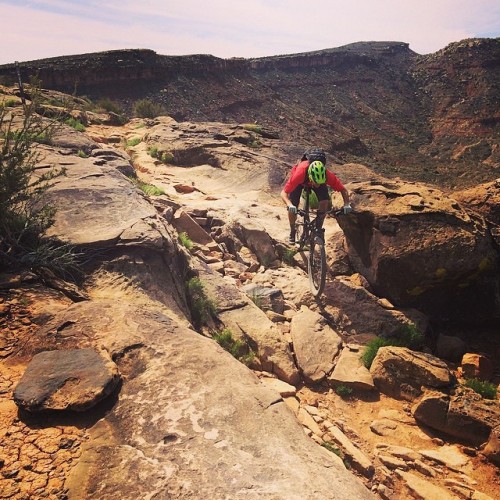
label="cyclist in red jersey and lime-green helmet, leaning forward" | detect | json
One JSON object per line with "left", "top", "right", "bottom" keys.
{"left": 281, "top": 148, "right": 352, "bottom": 244}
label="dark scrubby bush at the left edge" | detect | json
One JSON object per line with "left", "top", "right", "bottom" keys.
{"left": 0, "top": 85, "right": 75, "bottom": 274}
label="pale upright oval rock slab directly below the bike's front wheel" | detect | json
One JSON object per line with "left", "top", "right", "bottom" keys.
{"left": 290, "top": 307, "right": 342, "bottom": 383}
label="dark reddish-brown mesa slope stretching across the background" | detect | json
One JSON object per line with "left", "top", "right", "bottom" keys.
{"left": 0, "top": 39, "right": 500, "bottom": 187}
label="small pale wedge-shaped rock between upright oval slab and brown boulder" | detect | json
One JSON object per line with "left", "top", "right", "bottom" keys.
{"left": 328, "top": 346, "right": 375, "bottom": 391}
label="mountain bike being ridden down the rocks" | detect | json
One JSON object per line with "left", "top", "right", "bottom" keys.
{"left": 295, "top": 187, "right": 343, "bottom": 297}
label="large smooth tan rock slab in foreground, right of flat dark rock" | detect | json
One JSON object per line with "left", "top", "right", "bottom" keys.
{"left": 26, "top": 297, "right": 372, "bottom": 500}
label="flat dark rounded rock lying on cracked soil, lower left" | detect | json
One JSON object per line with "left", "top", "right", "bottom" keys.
{"left": 14, "top": 349, "right": 120, "bottom": 412}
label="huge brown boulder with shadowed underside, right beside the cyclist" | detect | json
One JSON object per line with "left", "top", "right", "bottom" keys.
{"left": 338, "top": 180, "right": 500, "bottom": 321}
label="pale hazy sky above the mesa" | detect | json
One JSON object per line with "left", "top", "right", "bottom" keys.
{"left": 0, "top": 0, "right": 500, "bottom": 64}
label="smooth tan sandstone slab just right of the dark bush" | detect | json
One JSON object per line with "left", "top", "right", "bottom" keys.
{"left": 45, "top": 151, "right": 173, "bottom": 251}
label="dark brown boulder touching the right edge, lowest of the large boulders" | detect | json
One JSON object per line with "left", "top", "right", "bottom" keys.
{"left": 412, "top": 387, "right": 500, "bottom": 446}
